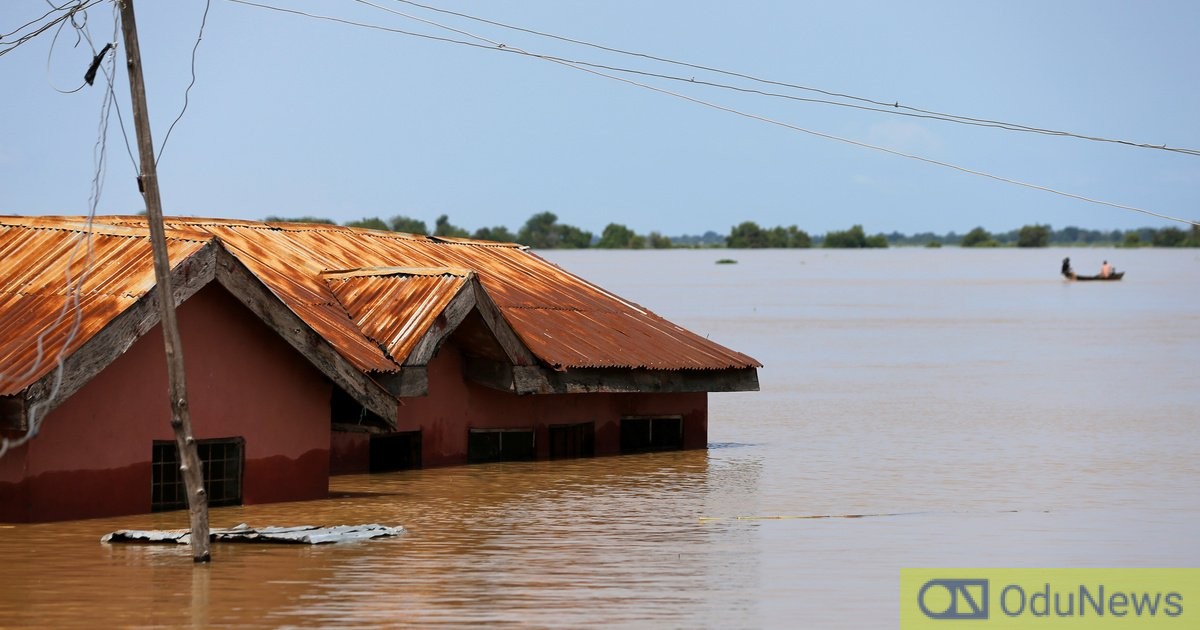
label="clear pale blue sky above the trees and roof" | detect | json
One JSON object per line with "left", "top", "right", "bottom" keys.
{"left": 0, "top": 0, "right": 1200, "bottom": 234}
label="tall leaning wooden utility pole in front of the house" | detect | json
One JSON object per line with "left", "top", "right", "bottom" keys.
{"left": 118, "top": 0, "right": 211, "bottom": 563}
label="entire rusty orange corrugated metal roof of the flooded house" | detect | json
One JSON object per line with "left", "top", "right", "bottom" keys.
{"left": 0, "top": 217, "right": 760, "bottom": 392}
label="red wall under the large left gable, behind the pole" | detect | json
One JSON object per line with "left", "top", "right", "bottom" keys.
{"left": 0, "top": 284, "right": 331, "bottom": 522}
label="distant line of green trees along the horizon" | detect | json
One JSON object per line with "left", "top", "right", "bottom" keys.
{"left": 266, "top": 212, "right": 1200, "bottom": 250}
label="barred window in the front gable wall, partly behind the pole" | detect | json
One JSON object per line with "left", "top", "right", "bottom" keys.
{"left": 150, "top": 438, "right": 246, "bottom": 512}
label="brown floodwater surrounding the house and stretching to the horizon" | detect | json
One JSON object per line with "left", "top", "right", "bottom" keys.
{"left": 0, "top": 248, "right": 1200, "bottom": 628}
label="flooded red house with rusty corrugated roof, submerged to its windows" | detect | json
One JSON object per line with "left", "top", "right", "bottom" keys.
{"left": 0, "top": 216, "right": 761, "bottom": 522}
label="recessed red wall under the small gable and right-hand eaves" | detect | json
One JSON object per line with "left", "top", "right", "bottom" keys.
{"left": 334, "top": 342, "right": 708, "bottom": 472}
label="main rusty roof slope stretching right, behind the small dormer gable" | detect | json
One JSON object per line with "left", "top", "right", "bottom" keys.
{"left": 179, "top": 220, "right": 760, "bottom": 370}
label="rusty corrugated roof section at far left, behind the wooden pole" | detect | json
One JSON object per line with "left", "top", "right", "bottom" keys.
{"left": 0, "top": 217, "right": 211, "bottom": 396}
